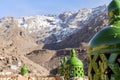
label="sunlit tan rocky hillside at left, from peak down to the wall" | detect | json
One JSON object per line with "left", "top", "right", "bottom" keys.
{"left": 0, "top": 20, "right": 49, "bottom": 75}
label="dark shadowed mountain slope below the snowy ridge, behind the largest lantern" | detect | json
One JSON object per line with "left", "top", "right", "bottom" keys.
{"left": 43, "top": 7, "right": 108, "bottom": 50}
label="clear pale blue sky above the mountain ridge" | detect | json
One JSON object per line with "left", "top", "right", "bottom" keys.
{"left": 0, "top": 0, "right": 111, "bottom": 18}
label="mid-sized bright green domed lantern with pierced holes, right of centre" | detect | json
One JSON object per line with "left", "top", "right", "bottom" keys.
{"left": 64, "top": 49, "right": 84, "bottom": 80}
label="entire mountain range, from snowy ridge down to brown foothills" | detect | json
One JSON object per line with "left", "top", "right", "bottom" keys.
{"left": 0, "top": 6, "right": 108, "bottom": 75}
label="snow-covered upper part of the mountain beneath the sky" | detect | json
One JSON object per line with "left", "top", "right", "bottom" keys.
{"left": 0, "top": 5, "right": 106, "bottom": 44}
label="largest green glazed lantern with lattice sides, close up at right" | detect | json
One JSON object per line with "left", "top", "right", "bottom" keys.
{"left": 87, "top": 0, "right": 120, "bottom": 80}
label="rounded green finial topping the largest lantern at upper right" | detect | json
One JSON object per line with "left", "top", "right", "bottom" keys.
{"left": 108, "top": 0, "right": 120, "bottom": 23}
